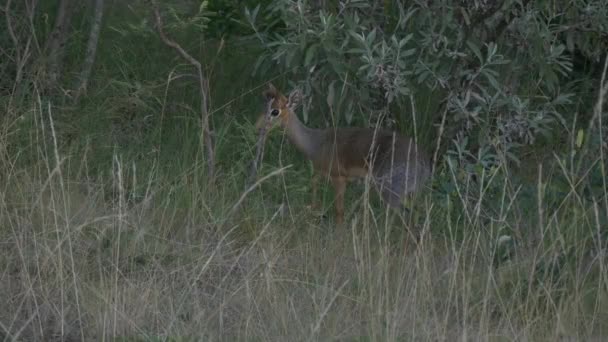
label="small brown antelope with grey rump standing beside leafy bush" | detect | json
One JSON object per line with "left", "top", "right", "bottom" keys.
{"left": 256, "top": 84, "right": 431, "bottom": 224}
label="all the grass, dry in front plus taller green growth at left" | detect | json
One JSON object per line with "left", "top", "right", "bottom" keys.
{"left": 0, "top": 7, "right": 608, "bottom": 341}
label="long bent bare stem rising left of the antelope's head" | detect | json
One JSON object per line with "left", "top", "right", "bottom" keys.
{"left": 151, "top": 0, "right": 215, "bottom": 185}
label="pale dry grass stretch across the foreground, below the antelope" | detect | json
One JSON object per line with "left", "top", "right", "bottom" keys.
{"left": 0, "top": 91, "right": 608, "bottom": 341}
